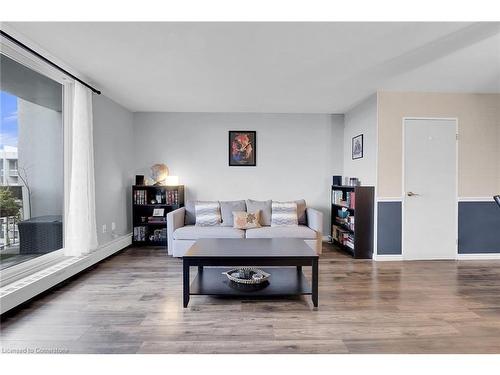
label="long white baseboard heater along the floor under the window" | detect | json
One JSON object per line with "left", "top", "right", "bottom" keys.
{"left": 0, "top": 233, "right": 132, "bottom": 314}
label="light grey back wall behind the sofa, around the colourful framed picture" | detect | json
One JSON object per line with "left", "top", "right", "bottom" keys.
{"left": 134, "top": 113, "right": 343, "bottom": 233}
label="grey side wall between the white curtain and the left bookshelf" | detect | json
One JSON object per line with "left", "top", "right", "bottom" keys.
{"left": 93, "top": 95, "right": 134, "bottom": 245}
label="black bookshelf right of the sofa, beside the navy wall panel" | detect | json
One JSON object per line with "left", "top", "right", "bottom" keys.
{"left": 330, "top": 185, "right": 375, "bottom": 259}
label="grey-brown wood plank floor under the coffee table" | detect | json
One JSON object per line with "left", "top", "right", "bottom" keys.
{"left": 0, "top": 245, "right": 500, "bottom": 353}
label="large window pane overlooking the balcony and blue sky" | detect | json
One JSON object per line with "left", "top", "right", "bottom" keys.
{"left": 0, "top": 54, "right": 64, "bottom": 269}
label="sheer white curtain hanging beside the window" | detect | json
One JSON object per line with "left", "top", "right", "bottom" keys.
{"left": 64, "top": 82, "right": 97, "bottom": 256}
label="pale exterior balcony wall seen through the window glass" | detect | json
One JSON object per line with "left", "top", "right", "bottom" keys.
{"left": 17, "top": 98, "right": 64, "bottom": 217}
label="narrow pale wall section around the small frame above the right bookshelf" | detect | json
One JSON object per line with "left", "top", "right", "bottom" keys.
{"left": 343, "top": 95, "right": 377, "bottom": 186}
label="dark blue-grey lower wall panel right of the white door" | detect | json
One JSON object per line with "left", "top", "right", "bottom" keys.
{"left": 458, "top": 201, "right": 500, "bottom": 254}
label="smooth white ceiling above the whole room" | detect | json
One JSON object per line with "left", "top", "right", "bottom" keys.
{"left": 4, "top": 22, "right": 500, "bottom": 113}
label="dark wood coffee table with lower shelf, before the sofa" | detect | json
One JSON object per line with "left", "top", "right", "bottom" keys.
{"left": 182, "top": 238, "right": 318, "bottom": 307}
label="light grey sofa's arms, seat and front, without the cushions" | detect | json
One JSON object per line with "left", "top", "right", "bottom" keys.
{"left": 167, "top": 202, "right": 323, "bottom": 257}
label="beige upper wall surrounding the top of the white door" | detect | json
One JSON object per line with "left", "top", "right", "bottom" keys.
{"left": 377, "top": 92, "right": 500, "bottom": 198}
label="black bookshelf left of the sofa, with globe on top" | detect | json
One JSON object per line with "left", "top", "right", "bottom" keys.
{"left": 132, "top": 185, "right": 184, "bottom": 246}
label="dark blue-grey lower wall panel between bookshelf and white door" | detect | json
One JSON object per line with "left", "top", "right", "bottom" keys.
{"left": 377, "top": 202, "right": 402, "bottom": 255}
